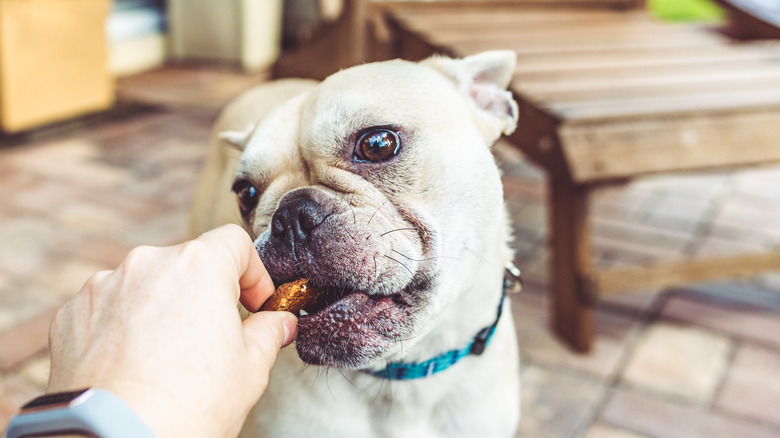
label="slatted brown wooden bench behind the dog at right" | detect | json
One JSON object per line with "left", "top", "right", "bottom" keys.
{"left": 272, "top": 0, "right": 780, "bottom": 351}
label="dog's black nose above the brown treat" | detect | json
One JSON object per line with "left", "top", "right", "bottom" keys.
{"left": 271, "top": 197, "right": 326, "bottom": 246}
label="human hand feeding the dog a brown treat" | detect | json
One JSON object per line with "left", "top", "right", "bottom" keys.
{"left": 49, "top": 225, "right": 297, "bottom": 437}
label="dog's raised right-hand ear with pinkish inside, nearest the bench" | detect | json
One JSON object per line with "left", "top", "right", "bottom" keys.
{"left": 423, "top": 50, "right": 519, "bottom": 142}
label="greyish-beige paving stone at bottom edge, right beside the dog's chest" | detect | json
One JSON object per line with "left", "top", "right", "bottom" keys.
{"left": 516, "top": 366, "right": 604, "bottom": 438}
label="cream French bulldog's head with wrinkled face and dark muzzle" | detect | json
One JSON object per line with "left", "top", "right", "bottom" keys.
{"left": 223, "top": 52, "right": 517, "bottom": 368}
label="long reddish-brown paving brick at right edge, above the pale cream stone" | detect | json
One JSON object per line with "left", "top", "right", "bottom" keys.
{"left": 661, "top": 297, "right": 780, "bottom": 348}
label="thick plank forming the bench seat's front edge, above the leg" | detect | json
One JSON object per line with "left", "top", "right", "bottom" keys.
{"left": 559, "top": 111, "right": 780, "bottom": 183}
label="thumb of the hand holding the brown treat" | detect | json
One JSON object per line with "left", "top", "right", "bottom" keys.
{"left": 243, "top": 312, "right": 298, "bottom": 372}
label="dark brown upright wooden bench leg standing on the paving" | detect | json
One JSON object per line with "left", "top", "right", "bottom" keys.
{"left": 549, "top": 179, "right": 594, "bottom": 352}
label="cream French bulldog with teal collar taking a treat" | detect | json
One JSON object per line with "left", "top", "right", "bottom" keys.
{"left": 191, "top": 51, "right": 520, "bottom": 438}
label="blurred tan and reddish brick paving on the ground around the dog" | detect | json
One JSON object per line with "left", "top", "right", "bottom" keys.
{"left": 0, "top": 66, "right": 780, "bottom": 438}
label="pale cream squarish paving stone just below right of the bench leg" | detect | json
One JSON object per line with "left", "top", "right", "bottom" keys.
{"left": 622, "top": 324, "right": 731, "bottom": 403}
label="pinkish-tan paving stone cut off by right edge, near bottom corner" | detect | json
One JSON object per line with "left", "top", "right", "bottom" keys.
{"left": 715, "top": 344, "right": 780, "bottom": 430}
